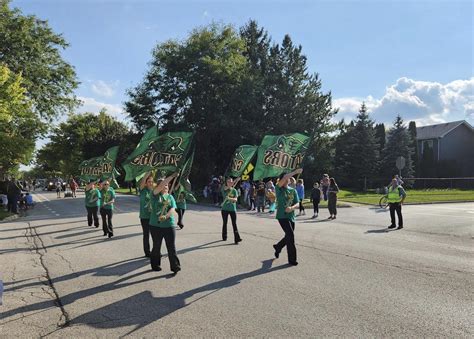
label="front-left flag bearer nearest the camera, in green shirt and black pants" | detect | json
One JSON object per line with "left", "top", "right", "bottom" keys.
{"left": 150, "top": 173, "right": 181, "bottom": 273}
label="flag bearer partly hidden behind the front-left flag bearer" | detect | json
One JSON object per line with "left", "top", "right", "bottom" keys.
{"left": 139, "top": 172, "right": 154, "bottom": 257}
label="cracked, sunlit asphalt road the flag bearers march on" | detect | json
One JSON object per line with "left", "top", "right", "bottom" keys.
{"left": 0, "top": 192, "right": 474, "bottom": 338}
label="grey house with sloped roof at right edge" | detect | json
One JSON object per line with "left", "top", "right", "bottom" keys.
{"left": 416, "top": 120, "right": 474, "bottom": 177}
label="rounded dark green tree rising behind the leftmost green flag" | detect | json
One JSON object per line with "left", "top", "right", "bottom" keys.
{"left": 36, "top": 110, "right": 131, "bottom": 176}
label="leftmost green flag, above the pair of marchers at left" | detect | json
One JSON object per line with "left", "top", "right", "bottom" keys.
{"left": 79, "top": 146, "right": 119, "bottom": 180}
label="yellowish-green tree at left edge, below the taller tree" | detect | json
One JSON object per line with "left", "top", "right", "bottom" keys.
{"left": 0, "top": 64, "right": 39, "bottom": 174}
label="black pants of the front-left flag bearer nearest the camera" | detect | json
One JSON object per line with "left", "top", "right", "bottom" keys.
{"left": 150, "top": 225, "right": 181, "bottom": 272}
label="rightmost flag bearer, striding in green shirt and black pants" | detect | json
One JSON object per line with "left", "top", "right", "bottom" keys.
{"left": 273, "top": 169, "right": 303, "bottom": 266}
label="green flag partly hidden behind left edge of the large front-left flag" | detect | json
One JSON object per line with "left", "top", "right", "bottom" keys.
{"left": 122, "top": 126, "right": 158, "bottom": 181}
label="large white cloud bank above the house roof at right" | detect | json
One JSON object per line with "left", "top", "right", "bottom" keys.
{"left": 334, "top": 77, "right": 474, "bottom": 126}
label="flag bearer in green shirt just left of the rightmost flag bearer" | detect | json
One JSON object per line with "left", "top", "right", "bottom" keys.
{"left": 221, "top": 177, "right": 242, "bottom": 245}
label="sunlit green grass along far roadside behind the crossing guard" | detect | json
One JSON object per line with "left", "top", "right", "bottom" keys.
{"left": 339, "top": 189, "right": 474, "bottom": 205}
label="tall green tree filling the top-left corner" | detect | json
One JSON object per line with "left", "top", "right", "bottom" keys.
{"left": 0, "top": 0, "right": 78, "bottom": 120}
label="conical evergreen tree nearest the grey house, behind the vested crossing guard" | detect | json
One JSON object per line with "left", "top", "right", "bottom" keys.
{"left": 381, "top": 115, "right": 413, "bottom": 178}
